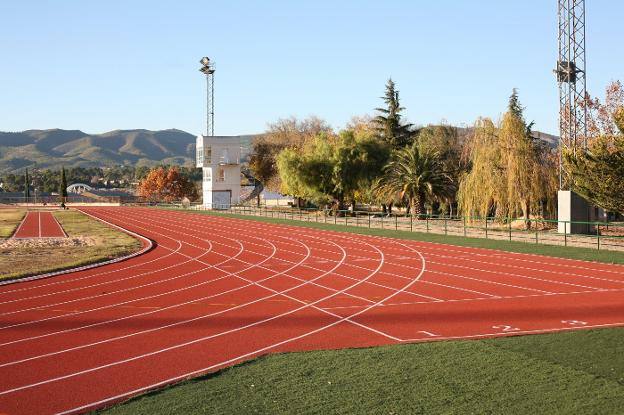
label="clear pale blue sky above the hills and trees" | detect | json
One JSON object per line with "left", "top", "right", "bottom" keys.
{"left": 0, "top": 0, "right": 624, "bottom": 135}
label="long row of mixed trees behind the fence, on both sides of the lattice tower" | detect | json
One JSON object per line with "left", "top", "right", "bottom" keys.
{"left": 249, "top": 79, "right": 624, "bottom": 221}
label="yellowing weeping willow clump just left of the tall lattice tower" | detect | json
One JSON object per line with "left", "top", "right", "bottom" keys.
{"left": 458, "top": 91, "right": 557, "bottom": 227}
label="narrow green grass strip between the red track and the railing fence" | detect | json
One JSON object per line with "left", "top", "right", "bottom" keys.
{"left": 159, "top": 208, "right": 624, "bottom": 264}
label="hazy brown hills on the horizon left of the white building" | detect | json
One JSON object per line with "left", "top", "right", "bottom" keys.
{"left": 0, "top": 129, "right": 195, "bottom": 173}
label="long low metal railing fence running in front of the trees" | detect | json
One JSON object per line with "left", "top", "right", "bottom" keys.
{"left": 158, "top": 203, "right": 624, "bottom": 251}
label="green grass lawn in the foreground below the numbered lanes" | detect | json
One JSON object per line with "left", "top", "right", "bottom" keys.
{"left": 103, "top": 328, "right": 624, "bottom": 415}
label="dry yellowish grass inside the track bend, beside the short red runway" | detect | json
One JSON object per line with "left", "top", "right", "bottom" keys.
{"left": 0, "top": 210, "right": 141, "bottom": 279}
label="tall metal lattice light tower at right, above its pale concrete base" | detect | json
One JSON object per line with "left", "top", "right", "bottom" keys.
{"left": 555, "top": 0, "right": 587, "bottom": 189}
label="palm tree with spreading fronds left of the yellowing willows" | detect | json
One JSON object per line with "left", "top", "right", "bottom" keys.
{"left": 376, "top": 143, "right": 454, "bottom": 216}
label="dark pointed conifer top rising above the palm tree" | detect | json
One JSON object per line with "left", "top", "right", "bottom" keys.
{"left": 373, "top": 78, "right": 414, "bottom": 149}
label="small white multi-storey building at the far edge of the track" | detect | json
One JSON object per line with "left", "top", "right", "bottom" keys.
{"left": 195, "top": 135, "right": 241, "bottom": 209}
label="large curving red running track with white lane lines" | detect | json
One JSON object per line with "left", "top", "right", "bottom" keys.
{"left": 0, "top": 207, "right": 624, "bottom": 414}
